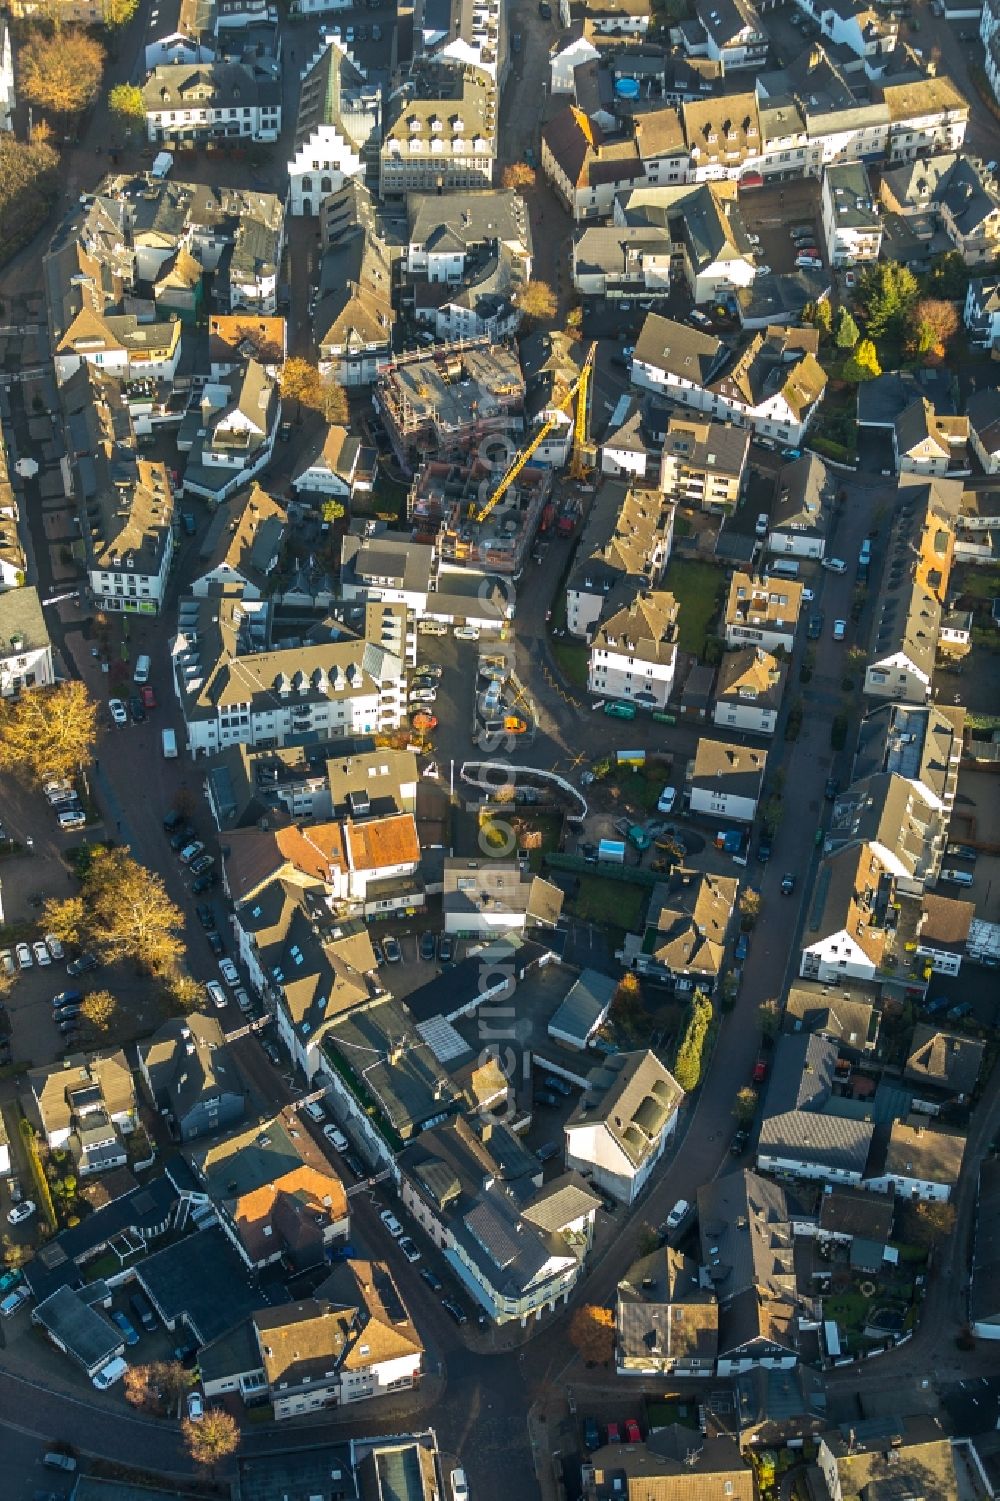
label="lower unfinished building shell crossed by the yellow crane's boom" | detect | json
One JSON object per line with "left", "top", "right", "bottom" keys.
{"left": 407, "top": 455, "right": 553, "bottom": 575}
